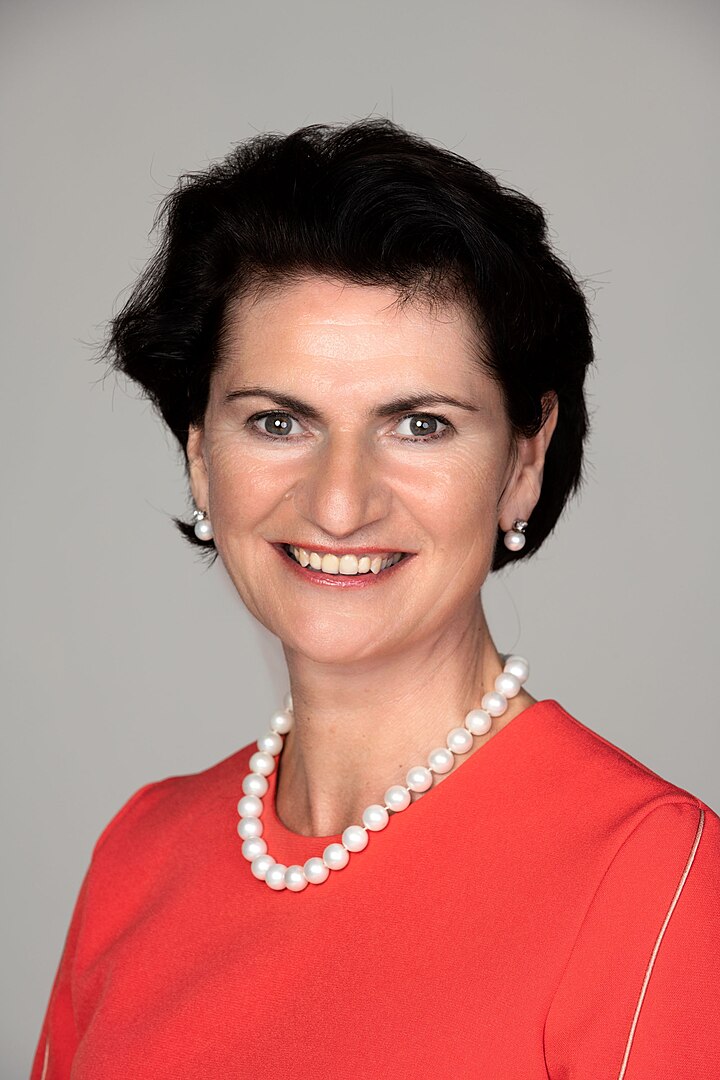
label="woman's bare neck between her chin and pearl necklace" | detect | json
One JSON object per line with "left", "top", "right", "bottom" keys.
{"left": 275, "top": 604, "right": 534, "bottom": 836}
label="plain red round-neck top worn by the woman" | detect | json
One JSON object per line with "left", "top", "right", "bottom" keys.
{"left": 32, "top": 700, "right": 720, "bottom": 1080}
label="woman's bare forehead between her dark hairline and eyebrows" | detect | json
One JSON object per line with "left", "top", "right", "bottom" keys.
{"left": 214, "top": 276, "right": 501, "bottom": 405}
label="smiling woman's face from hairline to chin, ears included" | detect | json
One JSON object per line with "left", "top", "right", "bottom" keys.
{"left": 188, "top": 278, "right": 552, "bottom": 662}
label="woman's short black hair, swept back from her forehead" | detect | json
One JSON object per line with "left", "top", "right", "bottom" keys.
{"left": 103, "top": 119, "right": 594, "bottom": 570}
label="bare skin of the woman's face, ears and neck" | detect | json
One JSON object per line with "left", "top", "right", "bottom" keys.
{"left": 187, "top": 276, "right": 557, "bottom": 837}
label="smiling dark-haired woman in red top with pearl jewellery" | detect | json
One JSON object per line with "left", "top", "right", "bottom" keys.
{"left": 32, "top": 121, "right": 720, "bottom": 1080}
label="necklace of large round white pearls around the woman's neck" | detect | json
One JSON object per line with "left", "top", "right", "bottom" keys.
{"left": 237, "top": 656, "right": 530, "bottom": 892}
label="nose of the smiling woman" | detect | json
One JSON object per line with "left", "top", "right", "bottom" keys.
{"left": 295, "top": 432, "right": 391, "bottom": 539}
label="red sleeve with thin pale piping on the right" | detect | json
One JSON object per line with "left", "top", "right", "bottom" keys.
{"left": 544, "top": 800, "right": 720, "bottom": 1080}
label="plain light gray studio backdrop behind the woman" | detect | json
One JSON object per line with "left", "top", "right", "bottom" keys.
{"left": 0, "top": 0, "right": 720, "bottom": 1078}
